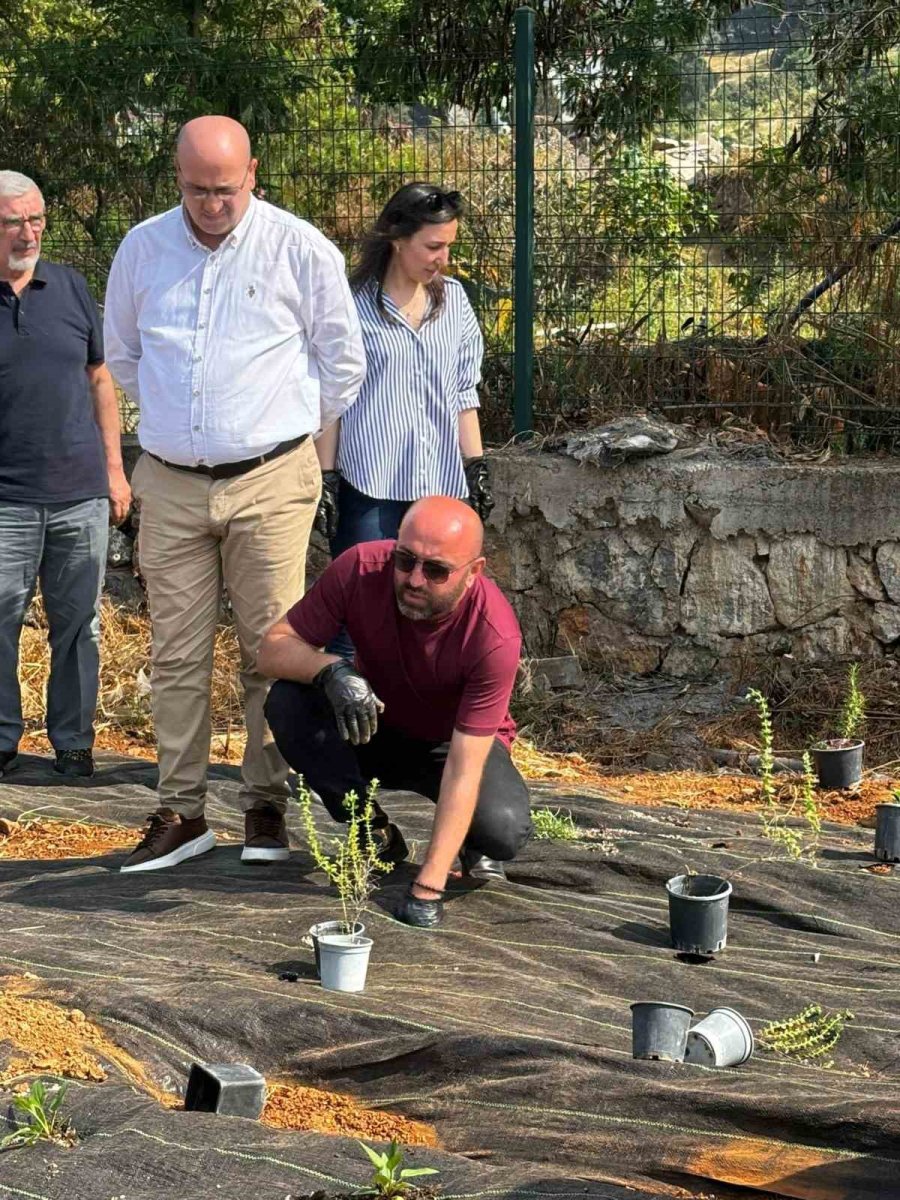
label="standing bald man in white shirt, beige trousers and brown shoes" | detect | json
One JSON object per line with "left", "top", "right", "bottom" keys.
{"left": 104, "top": 116, "right": 365, "bottom": 871}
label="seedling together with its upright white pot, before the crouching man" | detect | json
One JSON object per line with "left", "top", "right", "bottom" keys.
{"left": 298, "top": 780, "right": 390, "bottom": 991}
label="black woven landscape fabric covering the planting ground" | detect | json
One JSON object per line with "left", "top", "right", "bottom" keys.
{"left": 0, "top": 758, "right": 900, "bottom": 1200}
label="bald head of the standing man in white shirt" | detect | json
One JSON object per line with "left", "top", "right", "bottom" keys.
{"left": 175, "top": 116, "right": 257, "bottom": 250}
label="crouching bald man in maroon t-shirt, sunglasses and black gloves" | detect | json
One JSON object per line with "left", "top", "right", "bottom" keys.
{"left": 258, "top": 496, "right": 532, "bottom": 926}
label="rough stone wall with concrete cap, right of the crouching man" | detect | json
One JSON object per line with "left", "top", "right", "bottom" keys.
{"left": 488, "top": 448, "right": 900, "bottom": 677}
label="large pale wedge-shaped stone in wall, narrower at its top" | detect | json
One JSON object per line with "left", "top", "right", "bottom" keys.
{"left": 682, "top": 534, "right": 775, "bottom": 646}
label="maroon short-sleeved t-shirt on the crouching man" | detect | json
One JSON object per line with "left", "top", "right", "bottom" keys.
{"left": 288, "top": 541, "right": 522, "bottom": 746}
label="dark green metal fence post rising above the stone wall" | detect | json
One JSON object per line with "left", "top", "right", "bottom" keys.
{"left": 512, "top": 8, "right": 534, "bottom": 434}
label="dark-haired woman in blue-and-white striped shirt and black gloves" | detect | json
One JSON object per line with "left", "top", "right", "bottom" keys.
{"left": 318, "top": 182, "right": 493, "bottom": 571}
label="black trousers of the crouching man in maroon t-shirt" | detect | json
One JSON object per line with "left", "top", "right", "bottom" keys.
{"left": 265, "top": 679, "right": 532, "bottom": 862}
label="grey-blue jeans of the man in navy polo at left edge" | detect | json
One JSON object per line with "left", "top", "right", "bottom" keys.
{"left": 0, "top": 498, "right": 109, "bottom": 754}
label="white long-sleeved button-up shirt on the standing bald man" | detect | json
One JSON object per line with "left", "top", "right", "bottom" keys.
{"left": 103, "top": 197, "right": 365, "bottom": 467}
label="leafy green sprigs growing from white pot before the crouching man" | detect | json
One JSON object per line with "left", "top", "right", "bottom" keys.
{"left": 296, "top": 779, "right": 391, "bottom": 934}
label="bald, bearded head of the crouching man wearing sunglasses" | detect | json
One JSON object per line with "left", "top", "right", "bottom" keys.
{"left": 394, "top": 496, "right": 485, "bottom": 620}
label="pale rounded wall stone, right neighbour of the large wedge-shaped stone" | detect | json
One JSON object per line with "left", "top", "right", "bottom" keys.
{"left": 768, "top": 533, "right": 853, "bottom": 629}
